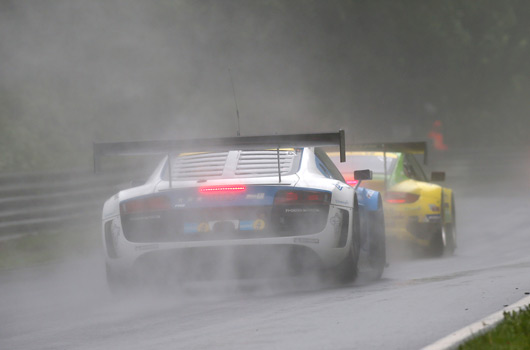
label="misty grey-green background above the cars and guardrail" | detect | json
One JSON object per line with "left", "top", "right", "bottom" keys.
{"left": 0, "top": 0, "right": 529, "bottom": 171}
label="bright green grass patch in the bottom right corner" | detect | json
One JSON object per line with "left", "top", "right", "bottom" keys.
{"left": 458, "top": 305, "right": 530, "bottom": 350}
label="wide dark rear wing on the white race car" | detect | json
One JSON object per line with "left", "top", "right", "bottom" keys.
{"left": 94, "top": 129, "right": 346, "bottom": 182}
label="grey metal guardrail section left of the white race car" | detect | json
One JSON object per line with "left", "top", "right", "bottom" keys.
{"left": 0, "top": 171, "right": 144, "bottom": 238}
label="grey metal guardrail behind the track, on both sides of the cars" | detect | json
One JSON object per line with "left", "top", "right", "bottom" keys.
{"left": 0, "top": 149, "right": 530, "bottom": 239}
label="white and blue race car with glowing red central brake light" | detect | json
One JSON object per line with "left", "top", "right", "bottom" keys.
{"left": 94, "top": 130, "right": 385, "bottom": 289}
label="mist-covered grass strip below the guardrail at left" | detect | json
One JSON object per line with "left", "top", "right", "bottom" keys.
{"left": 0, "top": 227, "right": 101, "bottom": 270}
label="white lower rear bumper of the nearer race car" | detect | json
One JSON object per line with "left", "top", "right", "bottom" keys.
{"left": 103, "top": 206, "right": 352, "bottom": 271}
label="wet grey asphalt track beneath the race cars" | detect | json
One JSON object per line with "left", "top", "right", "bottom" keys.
{"left": 0, "top": 151, "right": 530, "bottom": 349}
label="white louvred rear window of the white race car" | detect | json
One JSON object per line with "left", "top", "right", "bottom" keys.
{"left": 162, "top": 149, "right": 302, "bottom": 181}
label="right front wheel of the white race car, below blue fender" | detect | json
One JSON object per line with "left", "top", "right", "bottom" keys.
{"left": 368, "top": 209, "right": 386, "bottom": 279}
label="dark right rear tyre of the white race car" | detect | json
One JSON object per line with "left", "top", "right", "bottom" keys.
{"left": 335, "top": 199, "right": 361, "bottom": 284}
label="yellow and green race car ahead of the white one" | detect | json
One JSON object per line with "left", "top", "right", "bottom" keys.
{"left": 328, "top": 142, "right": 456, "bottom": 256}
